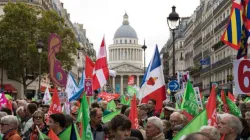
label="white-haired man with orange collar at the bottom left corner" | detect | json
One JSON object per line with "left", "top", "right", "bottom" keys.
{"left": 0, "top": 115, "right": 22, "bottom": 140}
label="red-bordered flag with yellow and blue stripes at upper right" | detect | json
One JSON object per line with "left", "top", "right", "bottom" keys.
{"left": 221, "top": 0, "right": 243, "bottom": 50}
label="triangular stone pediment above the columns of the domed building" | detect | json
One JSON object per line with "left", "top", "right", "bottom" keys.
{"left": 112, "top": 63, "right": 143, "bottom": 73}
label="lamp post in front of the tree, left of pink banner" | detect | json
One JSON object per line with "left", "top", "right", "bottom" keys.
{"left": 36, "top": 40, "right": 44, "bottom": 99}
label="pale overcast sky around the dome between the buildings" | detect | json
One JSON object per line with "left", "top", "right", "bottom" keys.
{"left": 61, "top": 0, "right": 200, "bottom": 63}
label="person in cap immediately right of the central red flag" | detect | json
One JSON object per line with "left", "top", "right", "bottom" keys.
{"left": 138, "top": 103, "right": 149, "bottom": 128}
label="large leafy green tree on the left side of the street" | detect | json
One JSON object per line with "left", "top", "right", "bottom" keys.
{"left": 0, "top": 2, "right": 79, "bottom": 98}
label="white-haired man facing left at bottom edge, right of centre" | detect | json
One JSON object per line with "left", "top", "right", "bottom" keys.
{"left": 146, "top": 116, "right": 165, "bottom": 140}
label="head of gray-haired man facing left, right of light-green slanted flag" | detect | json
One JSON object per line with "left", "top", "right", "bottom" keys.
{"left": 218, "top": 113, "right": 243, "bottom": 140}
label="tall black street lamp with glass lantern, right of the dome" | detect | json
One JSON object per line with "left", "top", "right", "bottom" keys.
{"left": 167, "top": 6, "right": 180, "bottom": 78}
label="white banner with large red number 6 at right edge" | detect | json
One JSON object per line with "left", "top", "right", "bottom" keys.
{"left": 233, "top": 59, "right": 250, "bottom": 94}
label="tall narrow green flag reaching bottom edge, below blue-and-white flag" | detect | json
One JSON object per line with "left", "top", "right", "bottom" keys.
{"left": 80, "top": 94, "right": 93, "bottom": 140}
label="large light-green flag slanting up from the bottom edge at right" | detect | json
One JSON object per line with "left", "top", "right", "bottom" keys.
{"left": 173, "top": 109, "right": 207, "bottom": 140}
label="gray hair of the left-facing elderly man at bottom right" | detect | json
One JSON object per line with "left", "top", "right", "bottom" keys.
{"left": 220, "top": 113, "right": 243, "bottom": 134}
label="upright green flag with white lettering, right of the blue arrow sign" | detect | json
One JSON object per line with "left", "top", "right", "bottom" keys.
{"left": 181, "top": 80, "right": 199, "bottom": 116}
